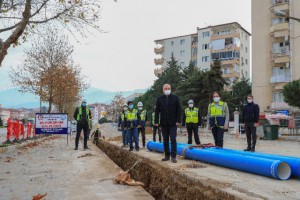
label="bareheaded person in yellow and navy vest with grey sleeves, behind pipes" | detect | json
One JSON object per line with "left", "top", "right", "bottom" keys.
{"left": 207, "top": 92, "right": 229, "bottom": 148}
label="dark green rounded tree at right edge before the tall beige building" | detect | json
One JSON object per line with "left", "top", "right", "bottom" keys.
{"left": 283, "top": 79, "right": 300, "bottom": 108}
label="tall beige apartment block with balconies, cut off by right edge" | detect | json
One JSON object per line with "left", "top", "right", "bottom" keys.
{"left": 252, "top": 0, "right": 300, "bottom": 113}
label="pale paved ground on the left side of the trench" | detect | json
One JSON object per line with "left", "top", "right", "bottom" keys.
{"left": 0, "top": 135, "right": 153, "bottom": 200}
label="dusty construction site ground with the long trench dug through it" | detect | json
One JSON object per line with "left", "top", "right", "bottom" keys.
{"left": 0, "top": 123, "right": 300, "bottom": 199}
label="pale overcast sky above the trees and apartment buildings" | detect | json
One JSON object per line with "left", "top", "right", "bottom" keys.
{"left": 0, "top": 0, "right": 251, "bottom": 91}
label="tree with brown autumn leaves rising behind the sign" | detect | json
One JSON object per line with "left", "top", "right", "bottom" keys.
{"left": 10, "top": 29, "right": 87, "bottom": 113}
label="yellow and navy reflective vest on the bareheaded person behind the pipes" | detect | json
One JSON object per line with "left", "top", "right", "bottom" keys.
{"left": 208, "top": 101, "right": 227, "bottom": 127}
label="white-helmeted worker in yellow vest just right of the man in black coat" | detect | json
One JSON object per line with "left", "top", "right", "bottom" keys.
{"left": 182, "top": 100, "right": 201, "bottom": 145}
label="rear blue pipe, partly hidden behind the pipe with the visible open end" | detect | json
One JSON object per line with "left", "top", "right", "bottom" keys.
{"left": 177, "top": 143, "right": 300, "bottom": 178}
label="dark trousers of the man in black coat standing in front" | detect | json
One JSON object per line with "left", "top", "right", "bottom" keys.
{"left": 162, "top": 126, "right": 177, "bottom": 158}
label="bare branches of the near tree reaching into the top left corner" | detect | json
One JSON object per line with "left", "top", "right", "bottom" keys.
{"left": 0, "top": 0, "right": 111, "bottom": 66}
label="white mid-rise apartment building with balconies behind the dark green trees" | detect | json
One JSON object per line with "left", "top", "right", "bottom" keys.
{"left": 154, "top": 22, "right": 251, "bottom": 87}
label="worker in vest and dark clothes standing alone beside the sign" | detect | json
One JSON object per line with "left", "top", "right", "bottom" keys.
{"left": 74, "top": 100, "right": 92, "bottom": 150}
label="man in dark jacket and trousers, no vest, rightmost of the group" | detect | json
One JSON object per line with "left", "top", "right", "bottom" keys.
{"left": 242, "top": 94, "right": 259, "bottom": 152}
